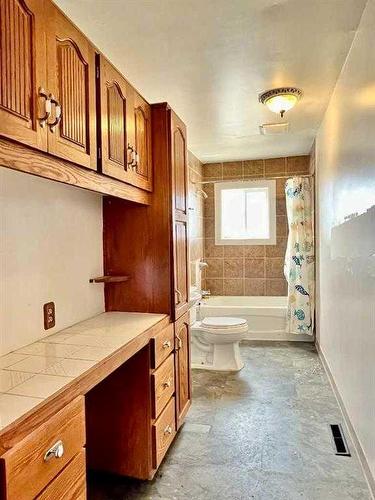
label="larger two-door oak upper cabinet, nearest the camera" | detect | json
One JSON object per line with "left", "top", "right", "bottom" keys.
{"left": 0, "top": 0, "right": 96, "bottom": 169}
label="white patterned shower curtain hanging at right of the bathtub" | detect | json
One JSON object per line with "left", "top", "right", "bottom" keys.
{"left": 284, "top": 177, "right": 315, "bottom": 335}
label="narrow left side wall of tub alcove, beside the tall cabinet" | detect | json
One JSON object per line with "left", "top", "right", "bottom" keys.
{"left": 188, "top": 151, "right": 205, "bottom": 289}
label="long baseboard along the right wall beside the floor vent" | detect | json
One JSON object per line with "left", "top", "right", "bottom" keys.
{"left": 315, "top": 341, "right": 375, "bottom": 499}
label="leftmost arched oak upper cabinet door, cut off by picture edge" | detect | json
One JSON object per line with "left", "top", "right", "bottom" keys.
{"left": 0, "top": 0, "right": 47, "bottom": 150}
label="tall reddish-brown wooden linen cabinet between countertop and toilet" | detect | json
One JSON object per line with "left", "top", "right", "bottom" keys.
{"left": 103, "top": 103, "right": 191, "bottom": 464}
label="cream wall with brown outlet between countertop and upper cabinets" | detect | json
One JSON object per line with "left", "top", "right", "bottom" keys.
{"left": 0, "top": 168, "right": 104, "bottom": 355}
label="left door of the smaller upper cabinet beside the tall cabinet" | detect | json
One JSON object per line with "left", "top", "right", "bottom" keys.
{"left": 98, "top": 56, "right": 132, "bottom": 182}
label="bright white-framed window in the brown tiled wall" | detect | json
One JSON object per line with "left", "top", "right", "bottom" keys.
{"left": 215, "top": 180, "right": 276, "bottom": 245}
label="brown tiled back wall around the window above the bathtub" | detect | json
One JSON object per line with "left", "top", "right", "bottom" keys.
{"left": 202, "top": 156, "right": 309, "bottom": 295}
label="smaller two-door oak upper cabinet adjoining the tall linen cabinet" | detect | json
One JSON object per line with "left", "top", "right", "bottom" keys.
{"left": 96, "top": 55, "right": 152, "bottom": 191}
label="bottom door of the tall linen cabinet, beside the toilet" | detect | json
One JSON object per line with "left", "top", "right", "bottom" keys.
{"left": 175, "top": 313, "right": 191, "bottom": 429}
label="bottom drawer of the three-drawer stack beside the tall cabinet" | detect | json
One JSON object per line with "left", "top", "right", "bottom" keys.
{"left": 152, "top": 397, "right": 176, "bottom": 469}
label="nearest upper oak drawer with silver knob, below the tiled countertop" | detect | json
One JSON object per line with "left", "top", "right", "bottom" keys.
{"left": 1, "top": 397, "right": 85, "bottom": 500}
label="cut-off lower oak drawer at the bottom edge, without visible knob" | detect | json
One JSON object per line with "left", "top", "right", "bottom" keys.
{"left": 36, "top": 449, "right": 86, "bottom": 500}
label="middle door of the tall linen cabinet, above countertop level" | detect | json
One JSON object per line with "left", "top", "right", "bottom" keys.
{"left": 173, "top": 220, "right": 189, "bottom": 319}
